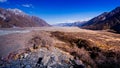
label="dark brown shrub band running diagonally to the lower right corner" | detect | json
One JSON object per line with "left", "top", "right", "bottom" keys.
{"left": 51, "top": 32, "right": 120, "bottom": 68}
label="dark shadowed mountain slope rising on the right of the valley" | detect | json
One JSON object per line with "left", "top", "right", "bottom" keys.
{"left": 82, "top": 7, "right": 120, "bottom": 33}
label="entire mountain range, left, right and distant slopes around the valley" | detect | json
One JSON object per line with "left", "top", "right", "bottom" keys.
{"left": 0, "top": 7, "right": 120, "bottom": 33}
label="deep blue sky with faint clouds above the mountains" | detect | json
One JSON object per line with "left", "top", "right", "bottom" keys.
{"left": 0, "top": 0, "right": 120, "bottom": 24}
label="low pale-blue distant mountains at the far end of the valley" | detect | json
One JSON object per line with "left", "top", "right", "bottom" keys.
{"left": 54, "top": 21, "right": 86, "bottom": 27}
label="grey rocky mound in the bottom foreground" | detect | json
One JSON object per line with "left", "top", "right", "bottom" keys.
{"left": 0, "top": 47, "right": 84, "bottom": 68}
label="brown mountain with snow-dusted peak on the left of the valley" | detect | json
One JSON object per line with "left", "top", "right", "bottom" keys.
{"left": 0, "top": 8, "right": 50, "bottom": 28}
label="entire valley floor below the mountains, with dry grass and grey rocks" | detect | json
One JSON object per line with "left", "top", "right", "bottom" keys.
{"left": 0, "top": 27, "right": 120, "bottom": 68}
